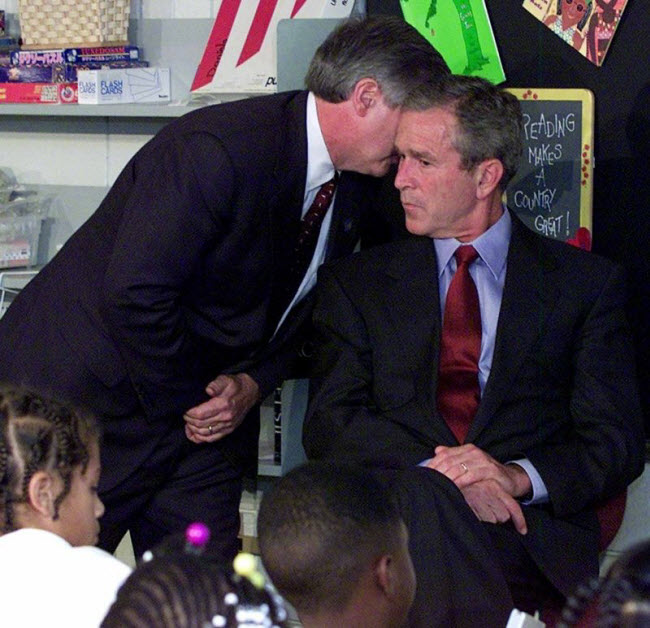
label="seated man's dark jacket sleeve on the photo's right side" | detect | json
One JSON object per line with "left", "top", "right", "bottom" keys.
{"left": 523, "top": 265, "right": 644, "bottom": 515}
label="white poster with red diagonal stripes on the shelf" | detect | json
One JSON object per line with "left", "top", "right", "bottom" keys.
{"left": 190, "top": 0, "right": 354, "bottom": 99}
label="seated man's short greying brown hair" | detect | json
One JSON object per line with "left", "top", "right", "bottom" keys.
{"left": 404, "top": 74, "right": 523, "bottom": 189}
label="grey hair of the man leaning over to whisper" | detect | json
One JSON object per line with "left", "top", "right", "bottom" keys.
{"left": 305, "top": 15, "right": 449, "bottom": 107}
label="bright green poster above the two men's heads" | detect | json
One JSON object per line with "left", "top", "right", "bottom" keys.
{"left": 400, "top": 0, "right": 506, "bottom": 83}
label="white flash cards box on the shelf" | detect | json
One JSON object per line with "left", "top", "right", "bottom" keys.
{"left": 77, "top": 67, "right": 171, "bottom": 105}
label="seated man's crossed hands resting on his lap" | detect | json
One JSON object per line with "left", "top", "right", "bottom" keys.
{"left": 425, "top": 444, "right": 531, "bottom": 534}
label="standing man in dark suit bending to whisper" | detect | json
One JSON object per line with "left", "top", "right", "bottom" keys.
{"left": 0, "top": 18, "right": 448, "bottom": 556}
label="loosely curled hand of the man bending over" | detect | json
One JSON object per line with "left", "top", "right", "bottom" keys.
{"left": 183, "top": 373, "right": 259, "bottom": 443}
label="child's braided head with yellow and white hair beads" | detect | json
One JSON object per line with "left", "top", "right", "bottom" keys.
{"left": 101, "top": 528, "right": 287, "bottom": 628}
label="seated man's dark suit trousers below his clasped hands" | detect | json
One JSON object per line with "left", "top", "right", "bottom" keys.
{"left": 380, "top": 467, "right": 554, "bottom": 628}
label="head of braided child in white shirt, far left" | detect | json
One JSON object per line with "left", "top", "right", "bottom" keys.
{"left": 0, "top": 387, "right": 104, "bottom": 546}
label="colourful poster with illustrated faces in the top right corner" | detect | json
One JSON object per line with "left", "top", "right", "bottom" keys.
{"left": 523, "top": 0, "right": 627, "bottom": 66}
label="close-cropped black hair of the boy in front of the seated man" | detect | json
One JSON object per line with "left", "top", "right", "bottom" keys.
{"left": 257, "top": 462, "right": 403, "bottom": 614}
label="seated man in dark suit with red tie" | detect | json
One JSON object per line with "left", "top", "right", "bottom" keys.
{"left": 303, "top": 76, "right": 643, "bottom": 626}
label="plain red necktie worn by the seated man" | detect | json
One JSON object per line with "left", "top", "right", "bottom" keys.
{"left": 438, "top": 245, "right": 481, "bottom": 444}
